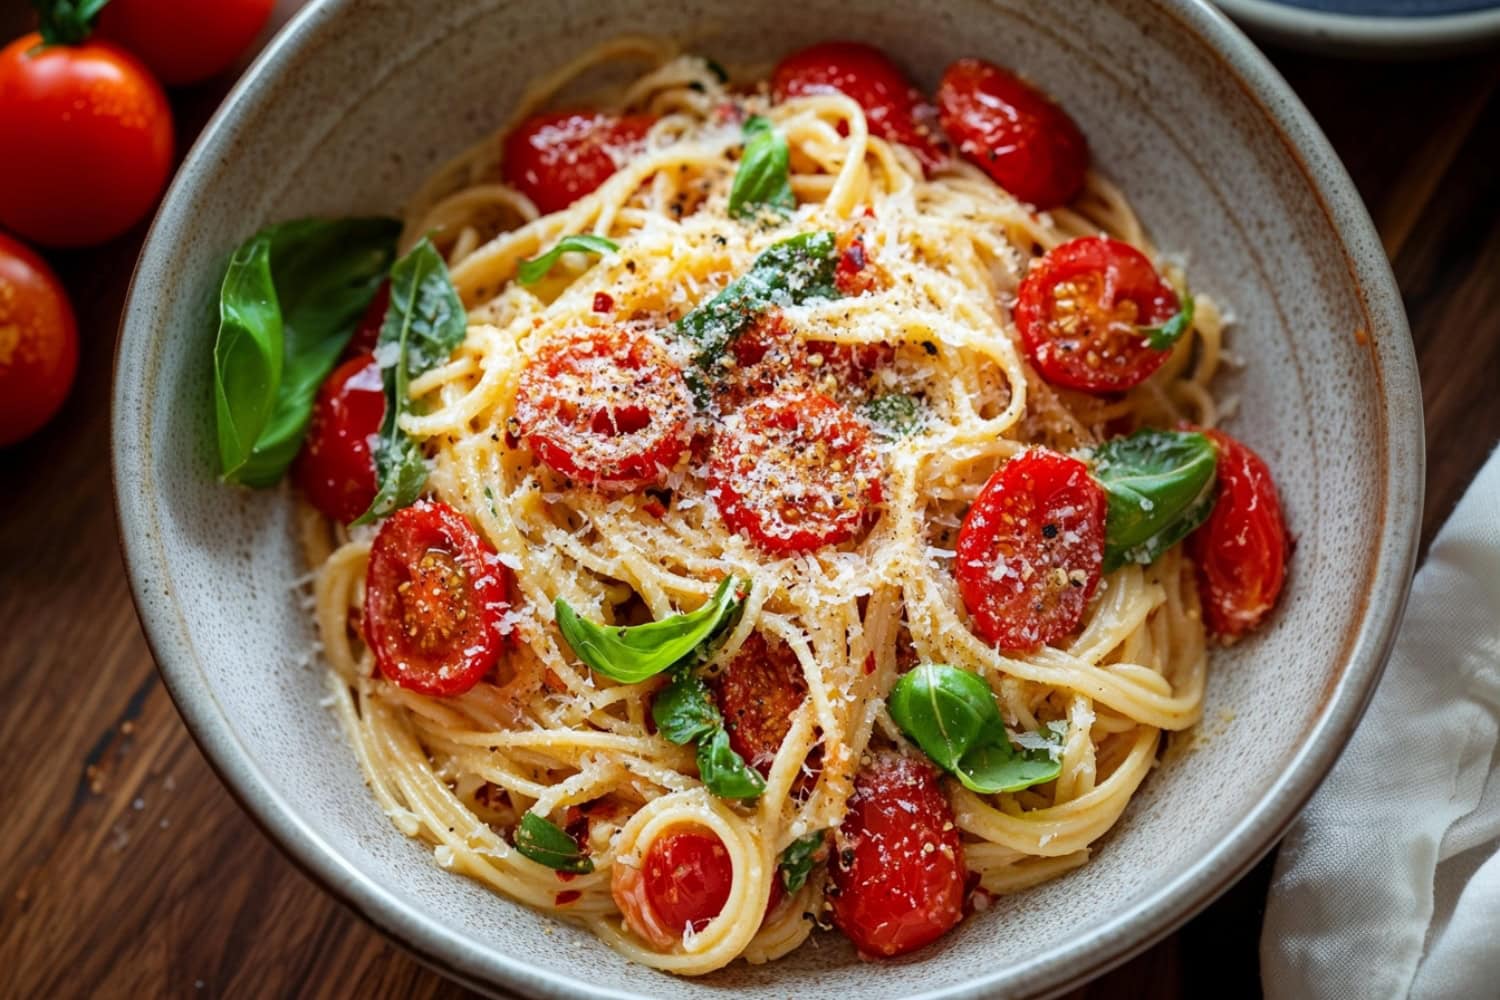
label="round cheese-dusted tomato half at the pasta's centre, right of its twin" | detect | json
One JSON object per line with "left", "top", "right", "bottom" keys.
{"left": 708, "top": 390, "right": 881, "bottom": 555}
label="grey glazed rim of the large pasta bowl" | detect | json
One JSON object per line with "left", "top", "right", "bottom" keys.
{"left": 111, "top": 0, "right": 1424, "bottom": 1000}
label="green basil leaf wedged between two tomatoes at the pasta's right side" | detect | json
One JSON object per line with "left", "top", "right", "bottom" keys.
{"left": 1094, "top": 427, "right": 1218, "bottom": 571}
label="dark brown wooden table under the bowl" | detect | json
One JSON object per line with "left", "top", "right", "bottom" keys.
{"left": 0, "top": 0, "right": 1500, "bottom": 997}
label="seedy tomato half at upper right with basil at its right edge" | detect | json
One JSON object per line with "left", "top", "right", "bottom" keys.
{"left": 1016, "top": 235, "right": 1181, "bottom": 393}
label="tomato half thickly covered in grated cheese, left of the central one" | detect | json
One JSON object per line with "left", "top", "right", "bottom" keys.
{"left": 515, "top": 327, "right": 693, "bottom": 490}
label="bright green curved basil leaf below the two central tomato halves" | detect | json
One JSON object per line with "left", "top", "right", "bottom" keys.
{"left": 555, "top": 576, "right": 750, "bottom": 684}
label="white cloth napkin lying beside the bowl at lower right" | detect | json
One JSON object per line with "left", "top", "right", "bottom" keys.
{"left": 1260, "top": 451, "right": 1500, "bottom": 1000}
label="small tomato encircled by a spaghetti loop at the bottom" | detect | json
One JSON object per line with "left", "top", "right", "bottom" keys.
{"left": 611, "top": 826, "right": 735, "bottom": 951}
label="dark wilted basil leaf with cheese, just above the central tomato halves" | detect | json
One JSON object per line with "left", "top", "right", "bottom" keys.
{"left": 677, "top": 232, "right": 839, "bottom": 370}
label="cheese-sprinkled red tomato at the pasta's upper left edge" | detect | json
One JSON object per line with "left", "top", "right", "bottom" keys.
{"left": 501, "top": 111, "right": 656, "bottom": 213}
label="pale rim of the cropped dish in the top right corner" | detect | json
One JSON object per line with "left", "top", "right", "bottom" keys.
{"left": 1214, "top": 0, "right": 1500, "bottom": 58}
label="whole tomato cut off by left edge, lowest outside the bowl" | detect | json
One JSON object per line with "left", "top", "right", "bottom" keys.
{"left": 0, "top": 235, "right": 78, "bottom": 447}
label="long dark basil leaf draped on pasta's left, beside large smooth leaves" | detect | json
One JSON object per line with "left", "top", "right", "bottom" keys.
{"left": 354, "top": 237, "right": 468, "bottom": 525}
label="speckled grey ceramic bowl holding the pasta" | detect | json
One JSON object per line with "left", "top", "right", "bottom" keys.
{"left": 114, "top": 0, "right": 1422, "bottom": 1000}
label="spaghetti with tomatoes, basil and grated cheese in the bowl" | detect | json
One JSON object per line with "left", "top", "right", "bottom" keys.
{"left": 208, "top": 39, "right": 1287, "bottom": 975}
